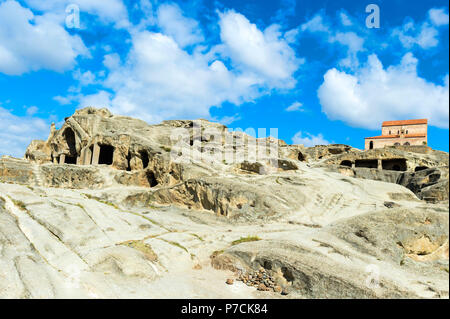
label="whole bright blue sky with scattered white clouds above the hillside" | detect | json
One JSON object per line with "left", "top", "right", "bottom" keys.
{"left": 0, "top": 0, "right": 449, "bottom": 157}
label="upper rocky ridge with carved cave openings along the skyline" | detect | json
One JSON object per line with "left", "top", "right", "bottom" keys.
{"left": 15, "top": 108, "right": 448, "bottom": 208}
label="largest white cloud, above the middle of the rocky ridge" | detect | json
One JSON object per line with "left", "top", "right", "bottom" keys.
{"left": 74, "top": 9, "right": 300, "bottom": 123}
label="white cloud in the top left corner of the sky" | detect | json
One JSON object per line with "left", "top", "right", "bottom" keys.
{"left": 0, "top": 0, "right": 88, "bottom": 75}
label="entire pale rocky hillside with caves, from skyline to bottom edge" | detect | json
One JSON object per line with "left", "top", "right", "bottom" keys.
{"left": 0, "top": 108, "right": 449, "bottom": 298}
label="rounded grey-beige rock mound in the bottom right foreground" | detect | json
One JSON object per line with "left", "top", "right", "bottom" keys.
{"left": 212, "top": 209, "right": 448, "bottom": 298}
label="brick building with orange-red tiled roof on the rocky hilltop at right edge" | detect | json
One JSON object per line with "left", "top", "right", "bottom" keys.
{"left": 364, "top": 119, "right": 428, "bottom": 150}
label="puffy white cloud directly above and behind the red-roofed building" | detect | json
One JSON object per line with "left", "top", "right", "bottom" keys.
{"left": 318, "top": 53, "right": 449, "bottom": 129}
